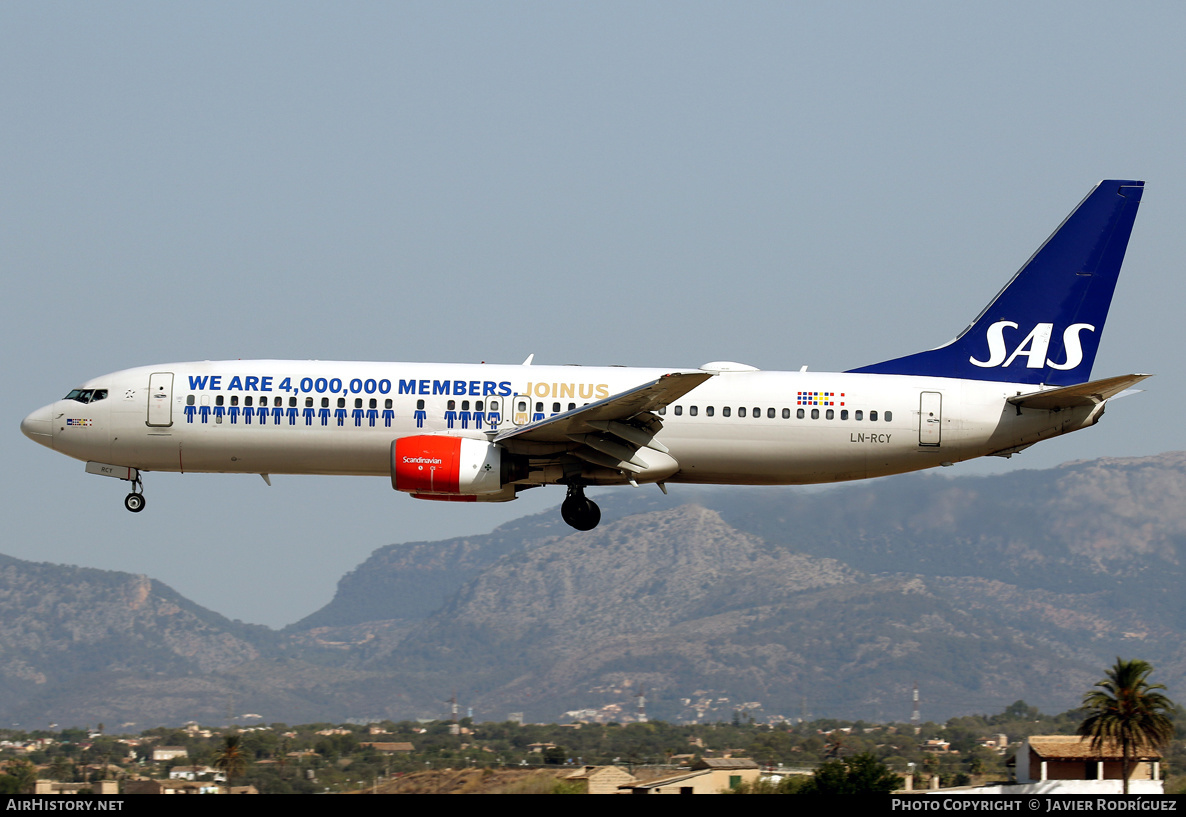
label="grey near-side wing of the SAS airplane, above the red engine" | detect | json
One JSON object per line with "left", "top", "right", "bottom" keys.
{"left": 493, "top": 371, "right": 713, "bottom": 447}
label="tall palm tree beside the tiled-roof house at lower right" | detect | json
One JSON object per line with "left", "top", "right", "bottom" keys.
{"left": 1078, "top": 658, "right": 1174, "bottom": 794}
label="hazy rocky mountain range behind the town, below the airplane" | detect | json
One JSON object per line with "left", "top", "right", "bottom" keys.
{"left": 0, "top": 453, "right": 1186, "bottom": 727}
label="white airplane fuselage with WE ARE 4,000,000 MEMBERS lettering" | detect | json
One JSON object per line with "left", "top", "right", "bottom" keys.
{"left": 23, "top": 360, "right": 1102, "bottom": 485}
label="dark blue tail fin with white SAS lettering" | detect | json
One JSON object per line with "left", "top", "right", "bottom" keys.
{"left": 852, "top": 180, "right": 1144, "bottom": 385}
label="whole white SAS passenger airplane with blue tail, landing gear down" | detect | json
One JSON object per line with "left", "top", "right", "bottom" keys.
{"left": 20, "top": 180, "right": 1149, "bottom": 530}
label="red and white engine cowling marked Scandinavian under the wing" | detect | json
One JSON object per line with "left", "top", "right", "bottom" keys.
{"left": 391, "top": 435, "right": 502, "bottom": 500}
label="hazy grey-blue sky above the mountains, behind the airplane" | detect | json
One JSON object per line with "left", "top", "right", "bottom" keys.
{"left": 0, "top": 0, "right": 1186, "bottom": 626}
